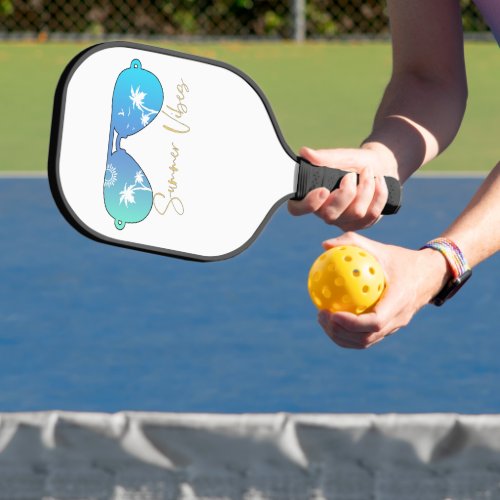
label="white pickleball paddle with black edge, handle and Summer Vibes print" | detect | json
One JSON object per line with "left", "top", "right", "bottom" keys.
{"left": 49, "top": 42, "right": 401, "bottom": 261}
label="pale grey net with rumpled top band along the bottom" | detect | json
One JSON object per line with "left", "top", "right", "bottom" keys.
{"left": 0, "top": 412, "right": 500, "bottom": 500}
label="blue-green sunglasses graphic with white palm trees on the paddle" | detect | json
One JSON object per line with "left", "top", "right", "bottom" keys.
{"left": 103, "top": 59, "right": 163, "bottom": 230}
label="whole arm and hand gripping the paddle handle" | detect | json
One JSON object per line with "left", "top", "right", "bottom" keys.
{"left": 289, "top": 0, "right": 467, "bottom": 230}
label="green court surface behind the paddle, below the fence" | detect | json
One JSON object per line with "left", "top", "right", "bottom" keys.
{"left": 0, "top": 42, "right": 500, "bottom": 171}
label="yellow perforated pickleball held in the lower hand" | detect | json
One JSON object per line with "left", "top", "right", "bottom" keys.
{"left": 307, "top": 245, "right": 385, "bottom": 314}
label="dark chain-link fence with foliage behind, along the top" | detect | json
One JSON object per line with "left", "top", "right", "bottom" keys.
{"left": 0, "top": 0, "right": 487, "bottom": 39}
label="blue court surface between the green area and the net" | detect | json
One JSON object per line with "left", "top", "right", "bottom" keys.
{"left": 0, "top": 178, "right": 500, "bottom": 413}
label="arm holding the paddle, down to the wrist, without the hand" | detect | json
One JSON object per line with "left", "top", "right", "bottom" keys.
{"left": 363, "top": 0, "right": 467, "bottom": 181}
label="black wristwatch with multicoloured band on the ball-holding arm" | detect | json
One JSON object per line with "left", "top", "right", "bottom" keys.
{"left": 421, "top": 238, "right": 472, "bottom": 306}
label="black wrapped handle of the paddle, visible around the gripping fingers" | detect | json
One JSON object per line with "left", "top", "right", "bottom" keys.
{"left": 292, "top": 158, "right": 402, "bottom": 215}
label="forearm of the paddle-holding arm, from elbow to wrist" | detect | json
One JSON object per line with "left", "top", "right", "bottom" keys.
{"left": 363, "top": 73, "right": 467, "bottom": 182}
